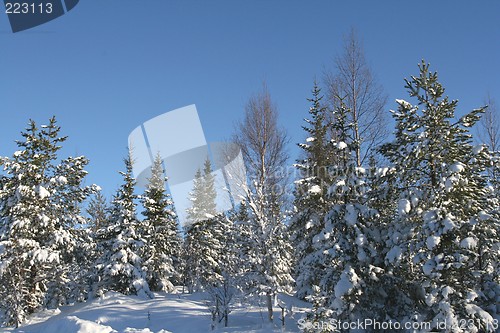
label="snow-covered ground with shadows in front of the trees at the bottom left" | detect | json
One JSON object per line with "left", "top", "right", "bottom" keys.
{"left": 0, "top": 292, "right": 308, "bottom": 333}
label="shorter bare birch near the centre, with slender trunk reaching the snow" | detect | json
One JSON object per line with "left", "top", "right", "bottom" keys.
{"left": 233, "top": 85, "right": 293, "bottom": 322}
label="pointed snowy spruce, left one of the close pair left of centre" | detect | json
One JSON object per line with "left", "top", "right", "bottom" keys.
{"left": 93, "top": 154, "right": 153, "bottom": 297}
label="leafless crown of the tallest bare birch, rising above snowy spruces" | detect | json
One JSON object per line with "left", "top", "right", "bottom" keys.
{"left": 325, "top": 30, "right": 387, "bottom": 166}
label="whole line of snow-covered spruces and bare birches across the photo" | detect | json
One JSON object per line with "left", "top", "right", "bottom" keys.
{"left": 0, "top": 31, "right": 500, "bottom": 332}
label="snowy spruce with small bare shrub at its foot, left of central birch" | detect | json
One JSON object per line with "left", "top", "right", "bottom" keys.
{"left": 184, "top": 160, "right": 241, "bottom": 328}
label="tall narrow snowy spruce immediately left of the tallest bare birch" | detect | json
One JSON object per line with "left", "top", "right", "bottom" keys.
{"left": 289, "top": 82, "right": 334, "bottom": 299}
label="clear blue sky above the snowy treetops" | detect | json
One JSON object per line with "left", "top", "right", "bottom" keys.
{"left": 0, "top": 0, "right": 500, "bottom": 196}
